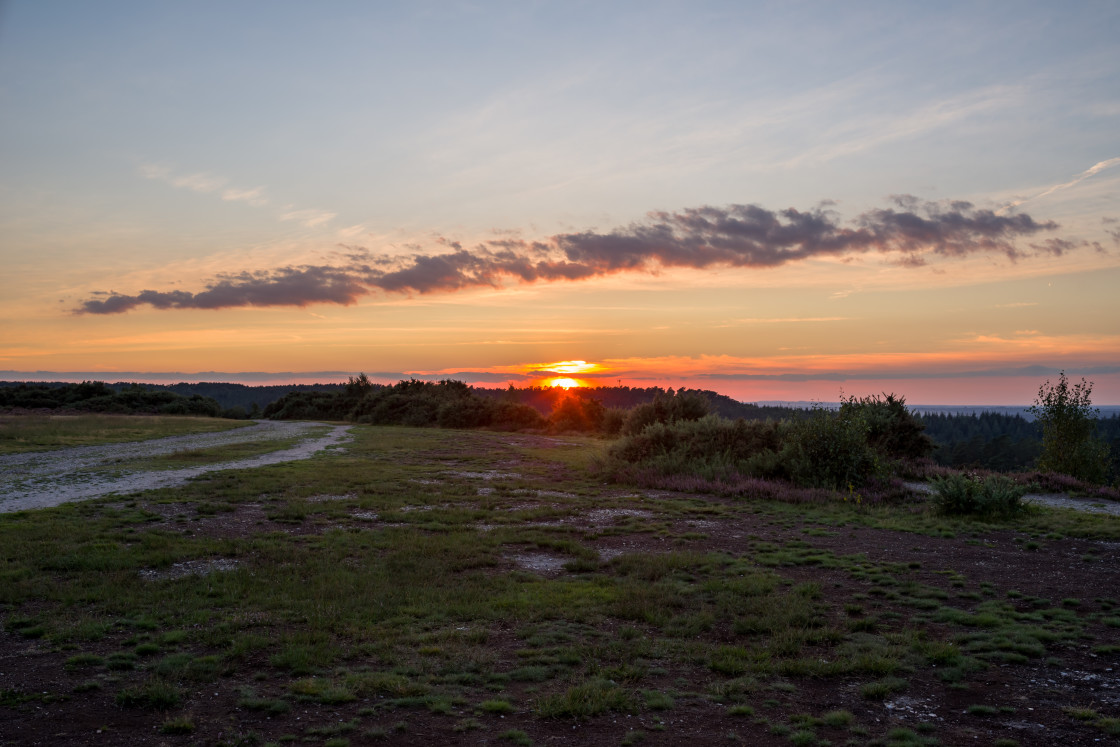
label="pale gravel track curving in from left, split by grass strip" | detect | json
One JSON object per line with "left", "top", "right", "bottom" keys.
{"left": 0, "top": 421, "right": 349, "bottom": 513}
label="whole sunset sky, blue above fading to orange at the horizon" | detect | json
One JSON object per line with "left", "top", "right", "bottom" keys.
{"left": 0, "top": 0, "right": 1120, "bottom": 405}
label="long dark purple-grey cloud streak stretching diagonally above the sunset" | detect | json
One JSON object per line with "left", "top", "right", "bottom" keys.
{"left": 76, "top": 195, "right": 1057, "bottom": 314}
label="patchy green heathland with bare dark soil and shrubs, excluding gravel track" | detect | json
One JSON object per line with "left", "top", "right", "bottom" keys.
{"left": 0, "top": 385, "right": 1120, "bottom": 746}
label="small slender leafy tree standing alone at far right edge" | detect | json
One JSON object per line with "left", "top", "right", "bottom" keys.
{"left": 1030, "top": 371, "right": 1109, "bottom": 483}
